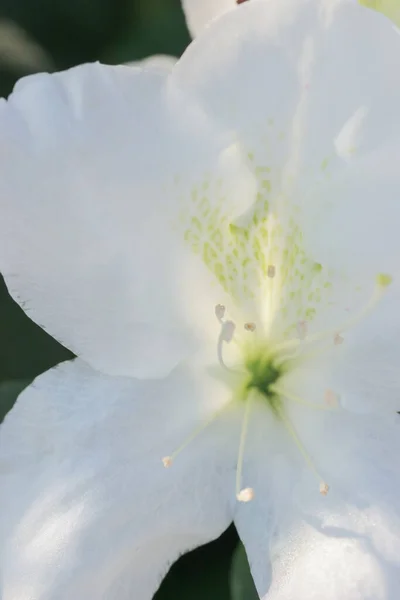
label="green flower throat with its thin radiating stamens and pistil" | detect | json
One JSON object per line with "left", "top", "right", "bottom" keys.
{"left": 162, "top": 273, "right": 392, "bottom": 502}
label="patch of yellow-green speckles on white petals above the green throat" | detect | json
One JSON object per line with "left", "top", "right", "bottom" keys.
{"left": 181, "top": 164, "right": 333, "bottom": 328}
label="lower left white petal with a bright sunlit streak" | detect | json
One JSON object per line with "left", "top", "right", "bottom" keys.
{"left": 0, "top": 359, "right": 236, "bottom": 600}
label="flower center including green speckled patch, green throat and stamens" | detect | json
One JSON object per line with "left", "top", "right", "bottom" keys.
{"left": 171, "top": 166, "right": 391, "bottom": 502}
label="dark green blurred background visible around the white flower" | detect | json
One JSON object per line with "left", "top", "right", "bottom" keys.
{"left": 0, "top": 0, "right": 256, "bottom": 600}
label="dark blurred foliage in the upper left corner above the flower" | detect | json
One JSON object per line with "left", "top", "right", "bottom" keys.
{"left": 0, "top": 0, "right": 189, "bottom": 96}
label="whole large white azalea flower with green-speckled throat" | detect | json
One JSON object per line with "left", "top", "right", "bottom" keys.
{"left": 0, "top": 0, "right": 400, "bottom": 600}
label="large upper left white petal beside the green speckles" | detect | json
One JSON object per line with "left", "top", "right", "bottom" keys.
{"left": 0, "top": 65, "right": 252, "bottom": 378}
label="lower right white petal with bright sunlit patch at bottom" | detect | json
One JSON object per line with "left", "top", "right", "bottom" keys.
{"left": 235, "top": 407, "right": 400, "bottom": 600}
